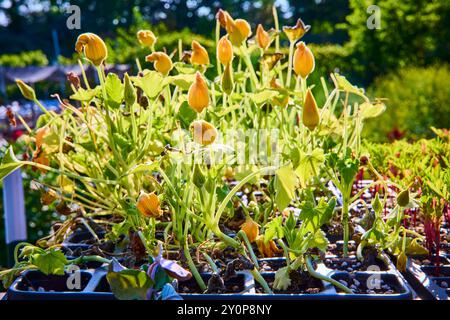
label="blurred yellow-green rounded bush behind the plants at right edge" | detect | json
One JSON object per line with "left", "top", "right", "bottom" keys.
{"left": 365, "top": 65, "right": 450, "bottom": 141}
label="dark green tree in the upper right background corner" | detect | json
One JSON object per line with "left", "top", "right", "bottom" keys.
{"left": 347, "top": 0, "right": 450, "bottom": 83}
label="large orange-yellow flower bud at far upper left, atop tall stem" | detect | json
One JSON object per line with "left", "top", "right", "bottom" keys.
{"left": 75, "top": 33, "right": 108, "bottom": 67}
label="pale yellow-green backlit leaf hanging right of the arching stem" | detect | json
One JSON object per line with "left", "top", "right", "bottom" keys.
{"left": 275, "top": 165, "right": 297, "bottom": 212}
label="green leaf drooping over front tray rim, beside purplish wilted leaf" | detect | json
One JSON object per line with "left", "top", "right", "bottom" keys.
{"left": 106, "top": 270, "right": 153, "bottom": 300}
